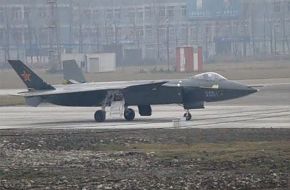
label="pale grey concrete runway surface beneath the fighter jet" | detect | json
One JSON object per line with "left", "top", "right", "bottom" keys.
{"left": 0, "top": 79, "right": 290, "bottom": 129}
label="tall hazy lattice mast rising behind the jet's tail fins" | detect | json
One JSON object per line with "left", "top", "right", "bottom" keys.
{"left": 47, "top": 0, "right": 61, "bottom": 72}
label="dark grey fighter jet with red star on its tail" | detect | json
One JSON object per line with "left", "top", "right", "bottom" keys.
{"left": 9, "top": 60, "right": 257, "bottom": 122}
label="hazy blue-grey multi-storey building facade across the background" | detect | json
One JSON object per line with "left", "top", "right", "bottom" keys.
{"left": 0, "top": 0, "right": 290, "bottom": 66}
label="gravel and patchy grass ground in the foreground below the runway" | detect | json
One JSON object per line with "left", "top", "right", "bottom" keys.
{"left": 0, "top": 129, "right": 290, "bottom": 190}
